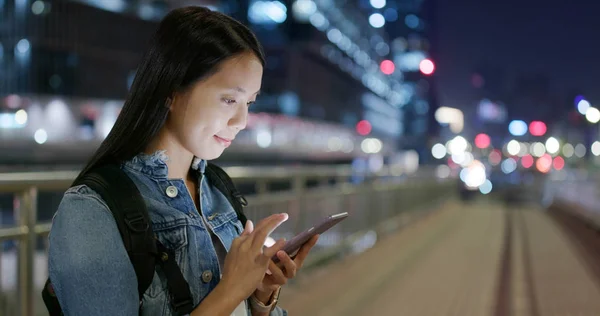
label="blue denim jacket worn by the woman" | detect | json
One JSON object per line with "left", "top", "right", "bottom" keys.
{"left": 48, "top": 152, "right": 287, "bottom": 316}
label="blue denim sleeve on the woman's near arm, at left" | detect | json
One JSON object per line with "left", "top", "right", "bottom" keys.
{"left": 48, "top": 186, "right": 139, "bottom": 316}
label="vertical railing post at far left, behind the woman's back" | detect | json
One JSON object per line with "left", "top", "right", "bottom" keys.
{"left": 15, "top": 187, "right": 38, "bottom": 316}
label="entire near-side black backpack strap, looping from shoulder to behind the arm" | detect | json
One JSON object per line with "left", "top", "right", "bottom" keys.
{"left": 42, "top": 165, "right": 193, "bottom": 316}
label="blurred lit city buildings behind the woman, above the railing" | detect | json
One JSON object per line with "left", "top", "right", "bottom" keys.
{"left": 0, "top": 0, "right": 437, "bottom": 170}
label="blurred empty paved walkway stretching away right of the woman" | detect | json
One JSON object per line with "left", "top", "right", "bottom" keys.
{"left": 281, "top": 201, "right": 600, "bottom": 316}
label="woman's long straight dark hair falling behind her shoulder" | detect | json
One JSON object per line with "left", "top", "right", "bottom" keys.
{"left": 79, "top": 7, "right": 265, "bottom": 181}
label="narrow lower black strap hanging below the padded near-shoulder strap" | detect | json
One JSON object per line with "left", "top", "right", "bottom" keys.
{"left": 156, "top": 240, "right": 194, "bottom": 315}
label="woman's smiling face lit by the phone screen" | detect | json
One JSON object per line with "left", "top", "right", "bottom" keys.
{"left": 165, "top": 53, "right": 263, "bottom": 160}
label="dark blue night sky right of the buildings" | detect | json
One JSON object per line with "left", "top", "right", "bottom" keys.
{"left": 435, "top": 0, "right": 600, "bottom": 113}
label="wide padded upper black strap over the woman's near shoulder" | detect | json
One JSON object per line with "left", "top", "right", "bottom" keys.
{"left": 75, "top": 165, "right": 157, "bottom": 301}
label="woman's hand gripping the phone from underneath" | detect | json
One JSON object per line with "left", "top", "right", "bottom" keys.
{"left": 254, "top": 235, "right": 319, "bottom": 303}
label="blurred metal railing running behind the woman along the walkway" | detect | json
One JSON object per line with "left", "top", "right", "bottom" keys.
{"left": 0, "top": 166, "right": 455, "bottom": 316}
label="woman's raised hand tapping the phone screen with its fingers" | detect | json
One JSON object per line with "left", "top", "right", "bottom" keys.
{"left": 221, "top": 214, "right": 288, "bottom": 302}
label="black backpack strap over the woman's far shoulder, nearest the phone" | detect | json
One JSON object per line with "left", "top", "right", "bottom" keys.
{"left": 204, "top": 162, "right": 248, "bottom": 226}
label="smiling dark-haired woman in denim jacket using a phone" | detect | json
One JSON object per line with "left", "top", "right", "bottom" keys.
{"left": 49, "top": 7, "right": 317, "bottom": 316}
